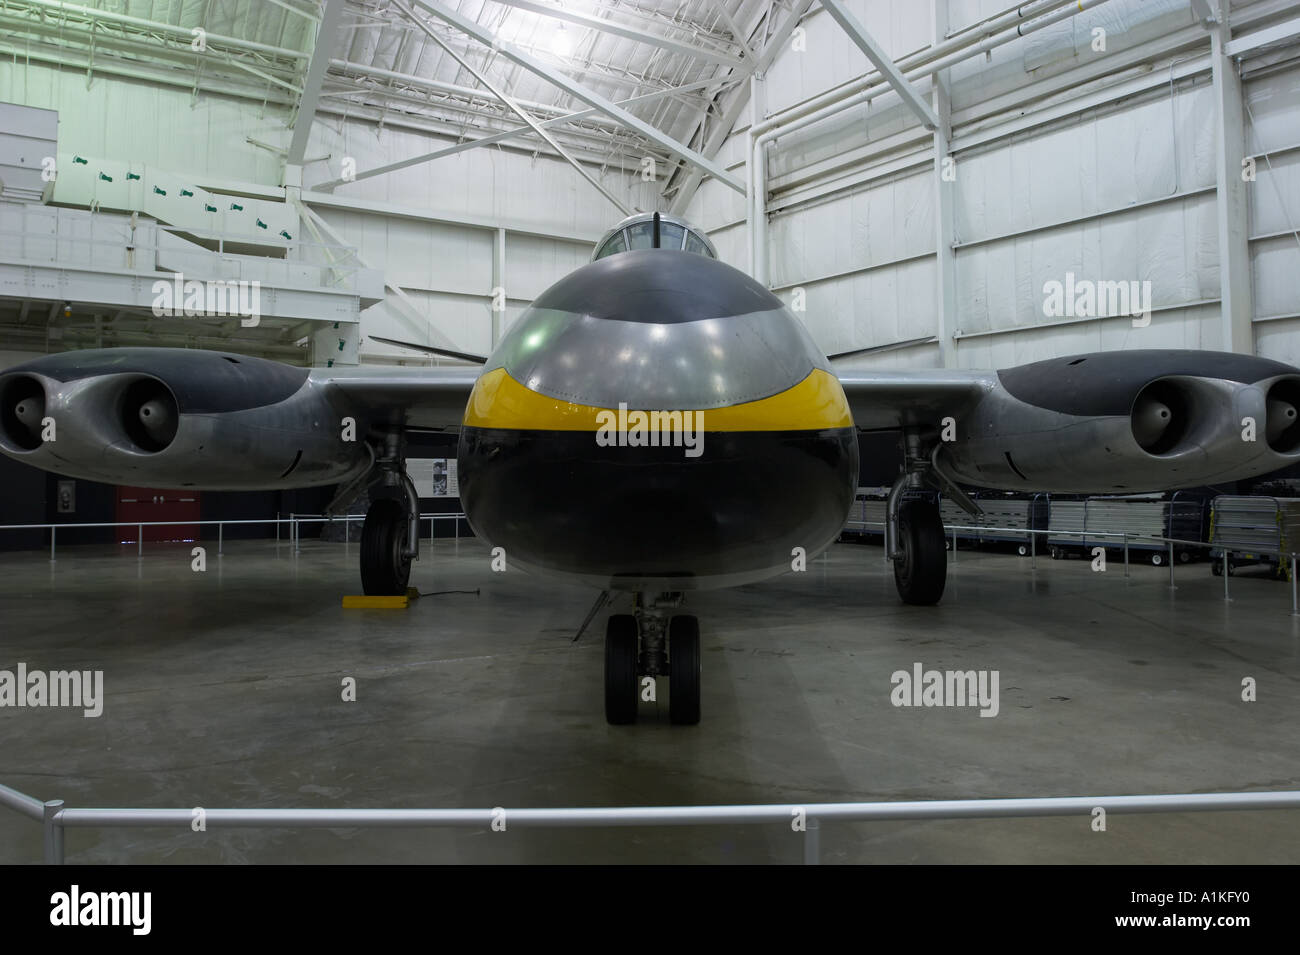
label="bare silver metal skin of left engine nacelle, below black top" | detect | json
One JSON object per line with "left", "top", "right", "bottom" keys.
{"left": 0, "top": 372, "right": 369, "bottom": 490}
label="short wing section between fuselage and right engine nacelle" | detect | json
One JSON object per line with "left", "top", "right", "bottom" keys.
{"left": 839, "top": 370, "right": 997, "bottom": 431}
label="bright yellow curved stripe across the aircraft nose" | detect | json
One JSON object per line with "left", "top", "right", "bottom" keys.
{"left": 464, "top": 368, "right": 853, "bottom": 431}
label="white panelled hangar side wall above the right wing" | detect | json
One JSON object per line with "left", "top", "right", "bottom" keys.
{"left": 688, "top": 0, "right": 1300, "bottom": 368}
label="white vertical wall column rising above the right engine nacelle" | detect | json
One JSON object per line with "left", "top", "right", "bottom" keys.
{"left": 1210, "top": 8, "right": 1255, "bottom": 355}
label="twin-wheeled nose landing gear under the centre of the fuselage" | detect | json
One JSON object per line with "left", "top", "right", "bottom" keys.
{"left": 605, "top": 592, "right": 699, "bottom": 725}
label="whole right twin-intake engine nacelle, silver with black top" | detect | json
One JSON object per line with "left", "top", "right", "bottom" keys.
{"left": 943, "top": 351, "right": 1300, "bottom": 492}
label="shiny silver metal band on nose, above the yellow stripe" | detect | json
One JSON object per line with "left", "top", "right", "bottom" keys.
{"left": 484, "top": 308, "right": 831, "bottom": 411}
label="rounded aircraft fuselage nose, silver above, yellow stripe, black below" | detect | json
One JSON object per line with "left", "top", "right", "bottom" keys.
{"left": 459, "top": 249, "right": 858, "bottom": 591}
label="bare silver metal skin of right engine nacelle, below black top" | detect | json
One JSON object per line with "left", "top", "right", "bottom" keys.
{"left": 941, "top": 376, "right": 1300, "bottom": 494}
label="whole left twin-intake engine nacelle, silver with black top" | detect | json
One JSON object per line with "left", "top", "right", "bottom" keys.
{"left": 0, "top": 348, "right": 371, "bottom": 490}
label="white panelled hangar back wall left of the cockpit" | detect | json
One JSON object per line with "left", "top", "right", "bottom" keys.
{"left": 0, "top": 58, "right": 657, "bottom": 364}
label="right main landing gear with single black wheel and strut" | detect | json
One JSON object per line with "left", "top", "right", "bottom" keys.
{"left": 885, "top": 431, "right": 982, "bottom": 605}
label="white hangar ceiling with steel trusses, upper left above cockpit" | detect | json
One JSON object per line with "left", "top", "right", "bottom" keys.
{"left": 0, "top": 0, "right": 810, "bottom": 199}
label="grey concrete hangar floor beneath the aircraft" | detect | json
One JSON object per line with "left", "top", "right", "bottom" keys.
{"left": 0, "top": 541, "right": 1300, "bottom": 863}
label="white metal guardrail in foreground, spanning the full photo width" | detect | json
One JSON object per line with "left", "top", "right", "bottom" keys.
{"left": 0, "top": 785, "right": 1300, "bottom": 865}
